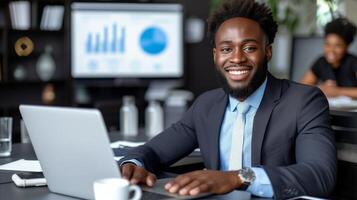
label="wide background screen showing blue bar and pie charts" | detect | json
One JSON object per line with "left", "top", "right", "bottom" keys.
{"left": 71, "top": 2, "right": 183, "bottom": 78}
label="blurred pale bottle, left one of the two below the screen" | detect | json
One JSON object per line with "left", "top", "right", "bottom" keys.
{"left": 120, "top": 96, "right": 138, "bottom": 136}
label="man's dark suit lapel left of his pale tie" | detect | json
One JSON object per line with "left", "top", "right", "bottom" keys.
{"left": 207, "top": 91, "right": 228, "bottom": 170}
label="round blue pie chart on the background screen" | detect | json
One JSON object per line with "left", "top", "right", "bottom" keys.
{"left": 140, "top": 27, "right": 167, "bottom": 55}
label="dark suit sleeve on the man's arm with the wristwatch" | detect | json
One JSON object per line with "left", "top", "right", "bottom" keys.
{"left": 263, "top": 89, "right": 337, "bottom": 199}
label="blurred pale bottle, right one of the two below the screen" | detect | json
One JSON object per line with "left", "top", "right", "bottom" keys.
{"left": 145, "top": 100, "right": 164, "bottom": 137}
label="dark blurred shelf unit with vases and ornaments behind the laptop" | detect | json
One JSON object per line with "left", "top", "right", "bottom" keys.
{"left": 0, "top": 0, "right": 73, "bottom": 144}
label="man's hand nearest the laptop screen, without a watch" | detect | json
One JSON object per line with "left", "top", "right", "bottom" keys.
{"left": 120, "top": 163, "right": 156, "bottom": 187}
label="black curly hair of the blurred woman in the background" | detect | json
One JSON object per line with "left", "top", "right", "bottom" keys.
{"left": 325, "top": 17, "right": 356, "bottom": 45}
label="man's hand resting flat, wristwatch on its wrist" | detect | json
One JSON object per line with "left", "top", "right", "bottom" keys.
{"left": 165, "top": 170, "right": 242, "bottom": 195}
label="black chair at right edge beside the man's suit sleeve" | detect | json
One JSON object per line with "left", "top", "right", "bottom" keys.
{"left": 330, "top": 110, "right": 357, "bottom": 199}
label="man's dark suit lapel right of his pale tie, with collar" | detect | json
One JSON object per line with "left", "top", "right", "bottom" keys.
{"left": 251, "top": 73, "right": 282, "bottom": 166}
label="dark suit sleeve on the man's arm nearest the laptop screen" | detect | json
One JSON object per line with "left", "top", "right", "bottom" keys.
{"left": 119, "top": 98, "right": 199, "bottom": 172}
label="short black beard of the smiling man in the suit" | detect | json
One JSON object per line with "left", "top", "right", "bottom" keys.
{"left": 217, "top": 59, "right": 268, "bottom": 100}
